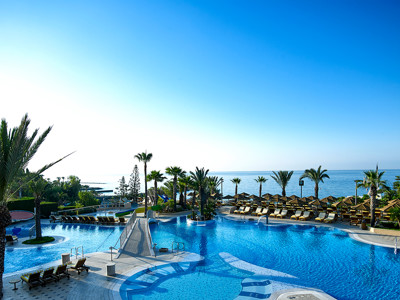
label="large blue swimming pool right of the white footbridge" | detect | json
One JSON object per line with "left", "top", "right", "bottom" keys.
{"left": 121, "top": 217, "right": 400, "bottom": 300}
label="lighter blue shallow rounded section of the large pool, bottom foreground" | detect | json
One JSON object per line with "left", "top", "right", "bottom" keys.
{"left": 120, "top": 255, "right": 253, "bottom": 300}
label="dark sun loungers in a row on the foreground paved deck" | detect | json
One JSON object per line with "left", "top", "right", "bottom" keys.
{"left": 21, "top": 258, "right": 89, "bottom": 289}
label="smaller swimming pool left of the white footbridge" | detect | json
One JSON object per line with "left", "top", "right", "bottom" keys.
{"left": 4, "top": 224, "right": 124, "bottom": 273}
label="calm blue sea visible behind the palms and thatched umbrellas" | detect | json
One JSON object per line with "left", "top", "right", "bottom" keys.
{"left": 101, "top": 169, "right": 400, "bottom": 199}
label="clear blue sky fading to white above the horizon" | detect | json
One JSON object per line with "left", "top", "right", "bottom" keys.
{"left": 0, "top": 0, "right": 400, "bottom": 181}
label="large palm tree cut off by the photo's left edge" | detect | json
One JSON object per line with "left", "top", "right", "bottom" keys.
{"left": 0, "top": 114, "right": 72, "bottom": 299}
